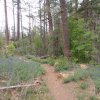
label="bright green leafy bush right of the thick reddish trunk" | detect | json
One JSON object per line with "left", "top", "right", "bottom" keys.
{"left": 69, "top": 17, "right": 92, "bottom": 62}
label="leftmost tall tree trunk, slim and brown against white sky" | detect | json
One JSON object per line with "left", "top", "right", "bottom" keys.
{"left": 4, "top": 0, "right": 9, "bottom": 45}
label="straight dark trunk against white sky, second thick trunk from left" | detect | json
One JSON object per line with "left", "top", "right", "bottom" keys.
{"left": 17, "top": 0, "right": 20, "bottom": 40}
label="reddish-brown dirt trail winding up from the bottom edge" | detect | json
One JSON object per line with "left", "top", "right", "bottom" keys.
{"left": 42, "top": 64, "right": 74, "bottom": 100}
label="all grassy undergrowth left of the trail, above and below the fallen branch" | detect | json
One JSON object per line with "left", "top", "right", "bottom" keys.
{"left": 0, "top": 57, "right": 52, "bottom": 100}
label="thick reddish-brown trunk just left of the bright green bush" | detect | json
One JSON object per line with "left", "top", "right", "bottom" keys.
{"left": 60, "top": 0, "right": 70, "bottom": 57}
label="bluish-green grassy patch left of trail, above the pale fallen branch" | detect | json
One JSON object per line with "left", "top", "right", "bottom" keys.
{"left": 0, "top": 57, "right": 44, "bottom": 85}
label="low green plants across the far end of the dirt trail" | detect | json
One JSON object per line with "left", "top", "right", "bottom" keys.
{"left": 26, "top": 56, "right": 79, "bottom": 72}
